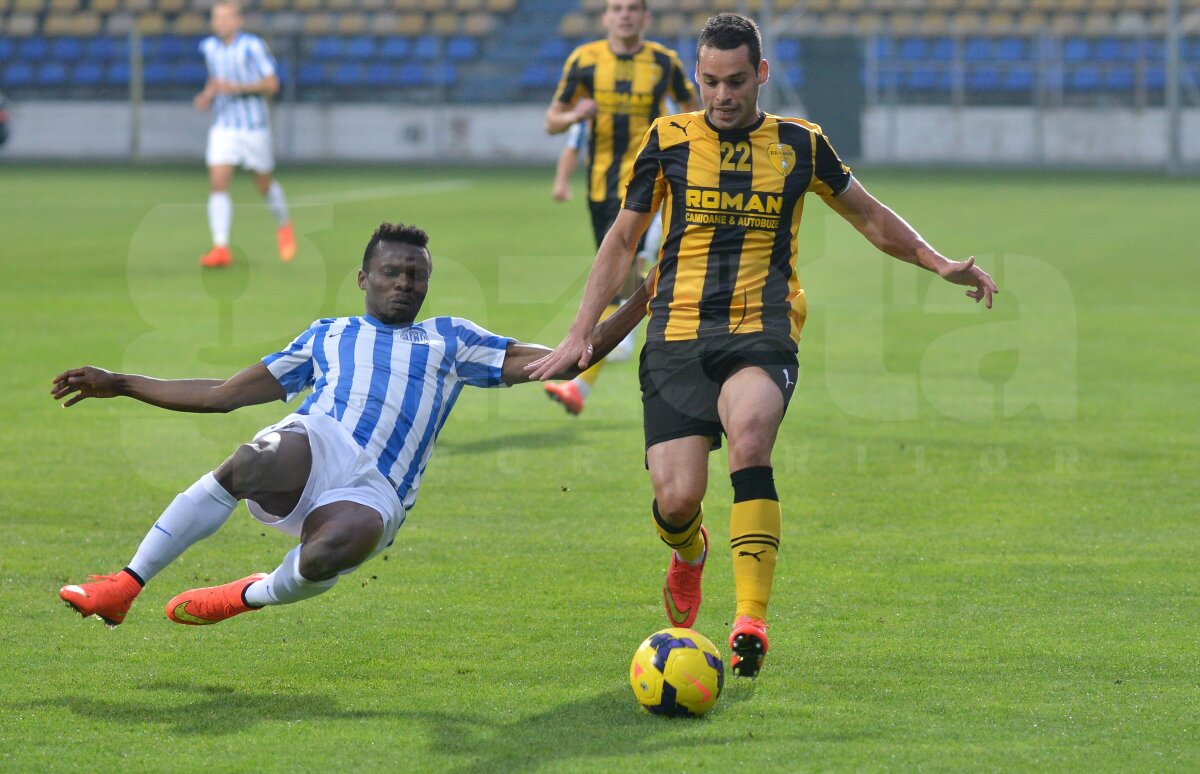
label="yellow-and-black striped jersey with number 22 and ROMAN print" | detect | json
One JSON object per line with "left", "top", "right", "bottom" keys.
{"left": 624, "top": 110, "right": 852, "bottom": 343}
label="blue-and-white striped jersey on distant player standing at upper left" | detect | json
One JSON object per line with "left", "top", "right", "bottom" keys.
{"left": 200, "top": 32, "right": 275, "bottom": 128}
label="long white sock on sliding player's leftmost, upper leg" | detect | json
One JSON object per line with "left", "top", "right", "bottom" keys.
{"left": 128, "top": 473, "right": 238, "bottom": 583}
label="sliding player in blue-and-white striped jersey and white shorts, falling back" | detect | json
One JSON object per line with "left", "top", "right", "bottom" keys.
{"left": 52, "top": 218, "right": 647, "bottom": 626}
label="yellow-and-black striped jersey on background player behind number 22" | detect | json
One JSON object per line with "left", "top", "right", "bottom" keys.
{"left": 554, "top": 40, "right": 696, "bottom": 202}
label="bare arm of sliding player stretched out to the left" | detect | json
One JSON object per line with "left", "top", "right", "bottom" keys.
{"left": 50, "top": 362, "right": 284, "bottom": 413}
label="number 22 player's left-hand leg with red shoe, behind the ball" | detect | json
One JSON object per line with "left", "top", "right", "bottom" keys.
{"left": 646, "top": 436, "right": 712, "bottom": 628}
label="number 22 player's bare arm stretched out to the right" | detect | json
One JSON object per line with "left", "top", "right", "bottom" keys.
{"left": 824, "top": 180, "right": 1000, "bottom": 308}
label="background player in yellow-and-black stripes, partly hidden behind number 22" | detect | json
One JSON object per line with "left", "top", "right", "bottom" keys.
{"left": 546, "top": 0, "right": 700, "bottom": 414}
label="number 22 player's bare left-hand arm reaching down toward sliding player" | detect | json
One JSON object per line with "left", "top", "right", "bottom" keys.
{"left": 526, "top": 210, "right": 653, "bottom": 380}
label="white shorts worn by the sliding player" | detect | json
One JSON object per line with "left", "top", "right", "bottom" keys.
{"left": 246, "top": 414, "right": 404, "bottom": 558}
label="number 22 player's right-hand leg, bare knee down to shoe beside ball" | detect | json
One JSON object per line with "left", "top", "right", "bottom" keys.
{"left": 718, "top": 366, "right": 794, "bottom": 677}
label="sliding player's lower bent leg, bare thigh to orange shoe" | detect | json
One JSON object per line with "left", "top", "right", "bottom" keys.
{"left": 167, "top": 502, "right": 384, "bottom": 625}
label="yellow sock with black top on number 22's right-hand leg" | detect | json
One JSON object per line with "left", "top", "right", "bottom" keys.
{"left": 730, "top": 466, "right": 782, "bottom": 619}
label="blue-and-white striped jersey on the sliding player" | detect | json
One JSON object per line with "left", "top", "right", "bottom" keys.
{"left": 263, "top": 314, "right": 512, "bottom": 510}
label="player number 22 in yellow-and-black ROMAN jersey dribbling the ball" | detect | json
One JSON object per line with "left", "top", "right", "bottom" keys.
{"left": 530, "top": 13, "right": 997, "bottom": 677}
